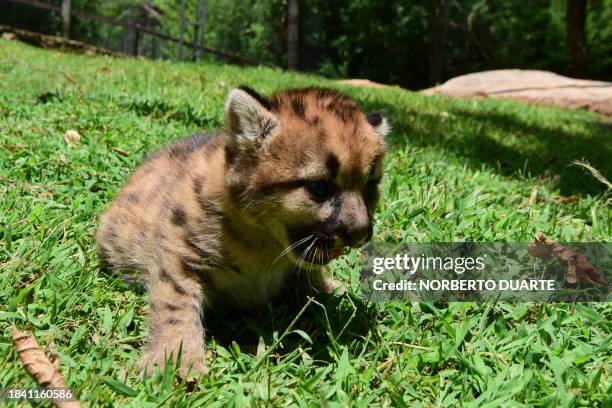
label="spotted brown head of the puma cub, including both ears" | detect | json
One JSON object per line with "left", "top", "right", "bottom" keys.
{"left": 226, "top": 88, "right": 389, "bottom": 267}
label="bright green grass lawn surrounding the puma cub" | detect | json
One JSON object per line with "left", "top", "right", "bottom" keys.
{"left": 0, "top": 40, "right": 612, "bottom": 407}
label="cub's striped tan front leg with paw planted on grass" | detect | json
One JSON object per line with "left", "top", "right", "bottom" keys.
{"left": 138, "top": 260, "right": 208, "bottom": 374}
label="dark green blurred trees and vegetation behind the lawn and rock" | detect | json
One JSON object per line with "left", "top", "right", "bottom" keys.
{"left": 0, "top": 0, "right": 612, "bottom": 89}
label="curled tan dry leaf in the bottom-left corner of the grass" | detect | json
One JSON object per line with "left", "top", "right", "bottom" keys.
{"left": 13, "top": 326, "right": 80, "bottom": 408}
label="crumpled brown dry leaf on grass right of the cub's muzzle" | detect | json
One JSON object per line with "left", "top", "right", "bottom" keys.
{"left": 527, "top": 232, "right": 606, "bottom": 287}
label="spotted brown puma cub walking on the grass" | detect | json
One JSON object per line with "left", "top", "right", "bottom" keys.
{"left": 97, "top": 88, "right": 389, "bottom": 372}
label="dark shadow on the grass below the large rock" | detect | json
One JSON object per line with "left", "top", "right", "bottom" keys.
{"left": 358, "top": 97, "right": 612, "bottom": 195}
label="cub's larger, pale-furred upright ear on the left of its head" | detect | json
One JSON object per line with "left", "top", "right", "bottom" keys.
{"left": 225, "top": 87, "right": 280, "bottom": 150}
